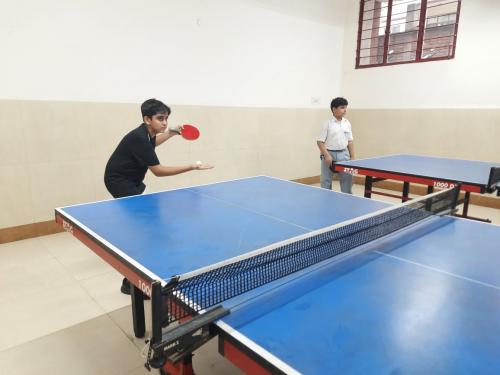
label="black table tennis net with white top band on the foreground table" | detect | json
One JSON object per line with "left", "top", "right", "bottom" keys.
{"left": 163, "top": 186, "right": 459, "bottom": 323}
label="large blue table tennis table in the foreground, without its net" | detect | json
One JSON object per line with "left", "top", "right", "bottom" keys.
{"left": 55, "top": 176, "right": 500, "bottom": 374}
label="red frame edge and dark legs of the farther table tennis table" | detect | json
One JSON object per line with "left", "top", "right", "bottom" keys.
{"left": 332, "top": 162, "right": 500, "bottom": 223}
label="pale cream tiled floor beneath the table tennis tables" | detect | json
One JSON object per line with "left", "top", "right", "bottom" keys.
{"left": 0, "top": 183, "right": 500, "bottom": 375}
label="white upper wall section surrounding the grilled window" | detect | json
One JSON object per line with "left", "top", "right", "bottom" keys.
{"left": 341, "top": 0, "right": 500, "bottom": 108}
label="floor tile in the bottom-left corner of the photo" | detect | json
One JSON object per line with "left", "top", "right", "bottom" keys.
{"left": 0, "top": 315, "right": 143, "bottom": 375}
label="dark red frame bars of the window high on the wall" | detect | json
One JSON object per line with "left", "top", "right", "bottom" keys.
{"left": 355, "top": 0, "right": 462, "bottom": 69}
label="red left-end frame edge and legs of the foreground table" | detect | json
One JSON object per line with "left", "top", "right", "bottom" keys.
{"left": 55, "top": 209, "right": 206, "bottom": 375}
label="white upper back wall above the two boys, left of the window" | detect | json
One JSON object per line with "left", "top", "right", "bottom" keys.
{"left": 0, "top": 0, "right": 349, "bottom": 107}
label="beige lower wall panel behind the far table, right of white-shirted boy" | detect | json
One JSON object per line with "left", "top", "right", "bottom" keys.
{"left": 349, "top": 109, "right": 500, "bottom": 162}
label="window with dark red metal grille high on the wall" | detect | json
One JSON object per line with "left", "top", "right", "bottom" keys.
{"left": 356, "top": 0, "right": 461, "bottom": 68}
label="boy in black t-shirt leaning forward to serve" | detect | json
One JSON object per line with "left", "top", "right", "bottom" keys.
{"left": 104, "top": 99, "right": 213, "bottom": 294}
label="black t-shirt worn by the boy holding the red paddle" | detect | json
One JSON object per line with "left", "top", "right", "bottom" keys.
{"left": 104, "top": 124, "right": 160, "bottom": 198}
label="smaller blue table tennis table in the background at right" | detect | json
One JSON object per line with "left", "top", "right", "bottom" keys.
{"left": 334, "top": 154, "right": 500, "bottom": 219}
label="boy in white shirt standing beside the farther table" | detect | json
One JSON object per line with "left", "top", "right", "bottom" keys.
{"left": 317, "top": 98, "right": 354, "bottom": 194}
